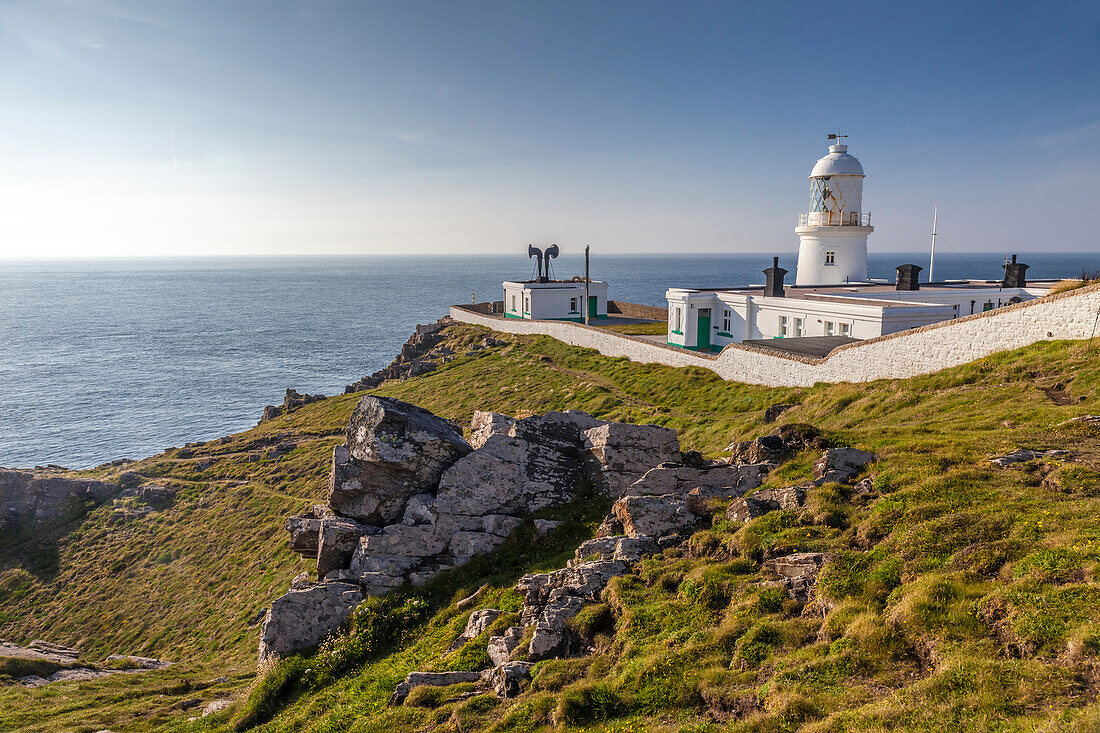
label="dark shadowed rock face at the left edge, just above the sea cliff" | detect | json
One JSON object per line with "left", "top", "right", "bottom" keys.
{"left": 0, "top": 469, "right": 120, "bottom": 532}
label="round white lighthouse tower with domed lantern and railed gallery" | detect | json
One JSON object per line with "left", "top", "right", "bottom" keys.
{"left": 794, "top": 134, "right": 875, "bottom": 285}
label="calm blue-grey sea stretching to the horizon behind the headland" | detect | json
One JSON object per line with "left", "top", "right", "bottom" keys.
{"left": 0, "top": 253, "right": 1100, "bottom": 468}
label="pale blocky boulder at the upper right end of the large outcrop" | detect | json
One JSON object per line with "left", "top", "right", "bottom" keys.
{"left": 583, "top": 423, "right": 680, "bottom": 497}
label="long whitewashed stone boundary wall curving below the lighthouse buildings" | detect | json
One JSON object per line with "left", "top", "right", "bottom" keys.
{"left": 451, "top": 285, "right": 1100, "bottom": 386}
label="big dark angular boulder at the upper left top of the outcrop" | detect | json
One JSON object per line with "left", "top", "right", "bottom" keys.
{"left": 328, "top": 396, "right": 472, "bottom": 526}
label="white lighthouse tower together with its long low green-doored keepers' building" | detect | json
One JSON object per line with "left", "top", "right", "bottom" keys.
{"left": 666, "top": 145, "right": 1049, "bottom": 351}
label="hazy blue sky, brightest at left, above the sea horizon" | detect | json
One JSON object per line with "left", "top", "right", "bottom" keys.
{"left": 0, "top": 0, "right": 1100, "bottom": 258}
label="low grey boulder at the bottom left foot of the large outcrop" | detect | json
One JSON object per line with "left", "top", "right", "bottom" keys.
{"left": 260, "top": 582, "right": 363, "bottom": 663}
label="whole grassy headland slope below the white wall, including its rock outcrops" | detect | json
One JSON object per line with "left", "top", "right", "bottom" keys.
{"left": 0, "top": 324, "right": 1100, "bottom": 732}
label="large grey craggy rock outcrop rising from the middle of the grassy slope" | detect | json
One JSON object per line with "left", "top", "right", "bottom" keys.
{"left": 261, "top": 396, "right": 686, "bottom": 657}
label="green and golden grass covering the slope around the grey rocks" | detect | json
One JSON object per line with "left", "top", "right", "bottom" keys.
{"left": 0, "top": 327, "right": 1100, "bottom": 731}
